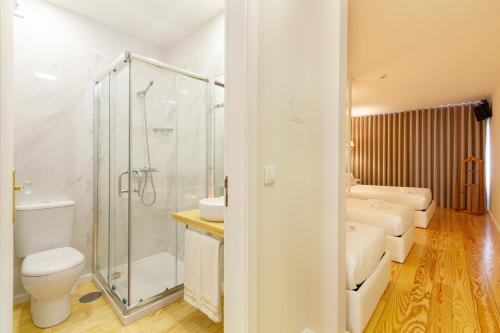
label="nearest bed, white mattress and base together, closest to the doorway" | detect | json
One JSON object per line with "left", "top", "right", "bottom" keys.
{"left": 346, "top": 222, "right": 391, "bottom": 333}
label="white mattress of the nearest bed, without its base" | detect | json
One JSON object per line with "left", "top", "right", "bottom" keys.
{"left": 346, "top": 222, "right": 385, "bottom": 290}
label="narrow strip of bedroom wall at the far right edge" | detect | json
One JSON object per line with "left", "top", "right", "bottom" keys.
{"left": 489, "top": 81, "right": 500, "bottom": 230}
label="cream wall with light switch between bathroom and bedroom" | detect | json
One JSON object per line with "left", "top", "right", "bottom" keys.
{"left": 252, "top": 0, "right": 346, "bottom": 332}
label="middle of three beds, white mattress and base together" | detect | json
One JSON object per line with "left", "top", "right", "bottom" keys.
{"left": 346, "top": 198, "right": 415, "bottom": 263}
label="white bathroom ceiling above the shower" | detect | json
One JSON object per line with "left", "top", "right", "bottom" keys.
{"left": 46, "top": 0, "right": 225, "bottom": 47}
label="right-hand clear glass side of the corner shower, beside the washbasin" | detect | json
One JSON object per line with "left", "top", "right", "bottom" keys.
{"left": 130, "top": 60, "right": 207, "bottom": 305}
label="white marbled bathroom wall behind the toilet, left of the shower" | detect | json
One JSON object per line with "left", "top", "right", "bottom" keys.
{"left": 14, "top": 0, "right": 162, "bottom": 294}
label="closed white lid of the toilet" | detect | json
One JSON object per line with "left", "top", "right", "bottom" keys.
{"left": 21, "top": 247, "right": 85, "bottom": 276}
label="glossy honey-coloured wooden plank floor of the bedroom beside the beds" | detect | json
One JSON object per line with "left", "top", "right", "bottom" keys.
{"left": 365, "top": 209, "right": 500, "bottom": 332}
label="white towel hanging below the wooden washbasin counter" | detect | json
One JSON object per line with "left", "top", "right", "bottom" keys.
{"left": 184, "top": 229, "right": 222, "bottom": 322}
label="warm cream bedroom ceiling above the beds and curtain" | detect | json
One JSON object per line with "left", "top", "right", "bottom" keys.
{"left": 349, "top": 0, "right": 500, "bottom": 115}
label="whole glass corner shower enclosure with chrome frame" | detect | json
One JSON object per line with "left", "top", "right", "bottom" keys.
{"left": 94, "top": 52, "right": 223, "bottom": 323}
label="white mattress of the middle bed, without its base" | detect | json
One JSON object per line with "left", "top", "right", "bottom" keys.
{"left": 346, "top": 198, "right": 414, "bottom": 236}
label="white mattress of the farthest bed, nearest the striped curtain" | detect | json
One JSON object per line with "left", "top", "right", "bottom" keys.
{"left": 350, "top": 185, "right": 432, "bottom": 210}
